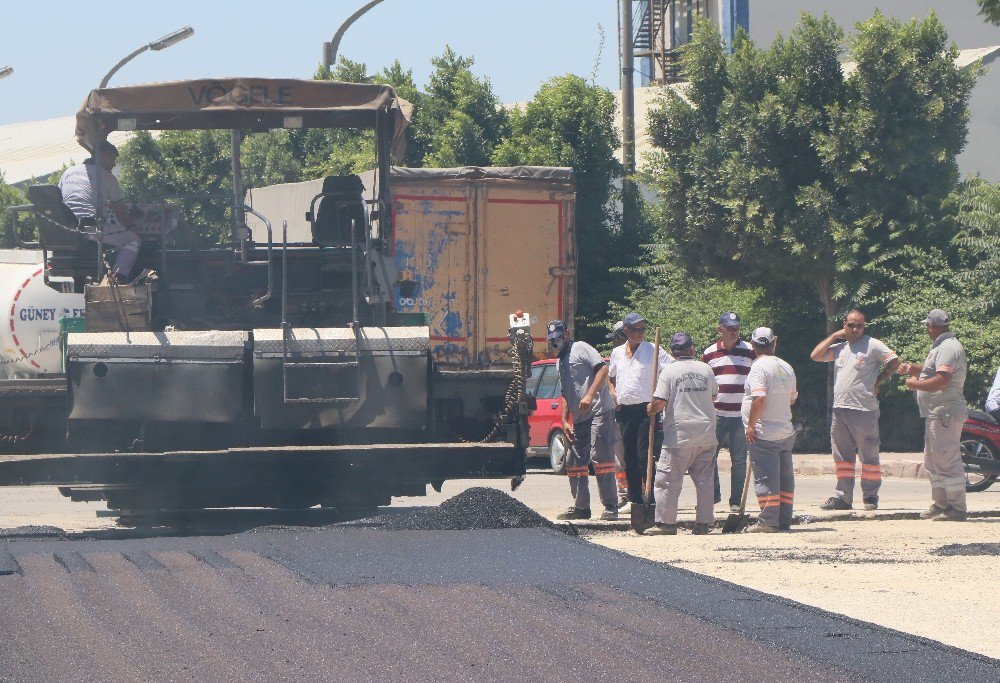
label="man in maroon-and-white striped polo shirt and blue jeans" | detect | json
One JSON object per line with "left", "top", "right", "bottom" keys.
{"left": 701, "top": 312, "right": 757, "bottom": 512}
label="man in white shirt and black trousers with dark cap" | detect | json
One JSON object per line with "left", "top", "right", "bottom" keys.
{"left": 608, "top": 313, "right": 673, "bottom": 503}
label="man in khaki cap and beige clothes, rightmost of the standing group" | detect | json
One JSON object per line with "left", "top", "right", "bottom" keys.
{"left": 899, "top": 308, "right": 969, "bottom": 522}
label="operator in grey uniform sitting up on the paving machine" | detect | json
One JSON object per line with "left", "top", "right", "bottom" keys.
{"left": 59, "top": 140, "right": 140, "bottom": 284}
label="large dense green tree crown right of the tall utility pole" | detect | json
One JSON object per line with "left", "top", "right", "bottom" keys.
{"left": 650, "top": 12, "right": 976, "bottom": 328}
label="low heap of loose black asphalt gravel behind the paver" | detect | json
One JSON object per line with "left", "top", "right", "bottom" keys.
{"left": 345, "top": 486, "right": 574, "bottom": 533}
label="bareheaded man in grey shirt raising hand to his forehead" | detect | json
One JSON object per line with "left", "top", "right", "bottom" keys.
{"left": 810, "top": 309, "right": 899, "bottom": 510}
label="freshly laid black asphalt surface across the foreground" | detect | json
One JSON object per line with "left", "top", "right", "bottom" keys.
{"left": 0, "top": 527, "right": 1000, "bottom": 683}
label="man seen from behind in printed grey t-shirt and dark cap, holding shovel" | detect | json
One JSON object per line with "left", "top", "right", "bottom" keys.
{"left": 646, "top": 332, "right": 719, "bottom": 536}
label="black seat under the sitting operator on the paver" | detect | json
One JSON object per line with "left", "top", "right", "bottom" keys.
{"left": 28, "top": 185, "right": 97, "bottom": 291}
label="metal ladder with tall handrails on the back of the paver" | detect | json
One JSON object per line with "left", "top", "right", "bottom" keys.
{"left": 281, "top": 219, "right": 362, "bottom": 404}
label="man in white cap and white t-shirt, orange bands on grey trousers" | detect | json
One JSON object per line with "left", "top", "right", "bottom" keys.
{"left": 742, "top": 327, "right": 799, "bottom": 533}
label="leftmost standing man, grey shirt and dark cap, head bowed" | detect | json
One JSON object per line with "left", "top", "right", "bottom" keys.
{"left": 546, "top": 320, "right": 618, "bottom": 520}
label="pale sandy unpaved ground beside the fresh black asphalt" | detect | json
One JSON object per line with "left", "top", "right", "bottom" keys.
{"left": 582, "top": 519, "right": 1000, "bottom": 658}
